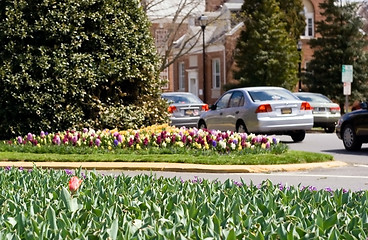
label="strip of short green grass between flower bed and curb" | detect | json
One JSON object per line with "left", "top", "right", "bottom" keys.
{"left": 0, "top": 150, "right": 333, "bottom": 165}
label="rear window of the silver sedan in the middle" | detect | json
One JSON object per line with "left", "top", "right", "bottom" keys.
{"left": 248, "top": 89, "right": 296, "bottom": 102}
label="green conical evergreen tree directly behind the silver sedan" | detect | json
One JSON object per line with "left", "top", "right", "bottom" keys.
{"left": 234, "top": 0, "right": 299, "bottom": 89}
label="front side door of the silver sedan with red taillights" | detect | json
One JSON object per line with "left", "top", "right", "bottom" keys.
{"left": 206, "top": 92, "right": 232, "bottom": 131}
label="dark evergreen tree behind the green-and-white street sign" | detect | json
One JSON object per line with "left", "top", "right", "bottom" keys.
{"left": 304, "top": 0, "right": 368, "bottom": 109}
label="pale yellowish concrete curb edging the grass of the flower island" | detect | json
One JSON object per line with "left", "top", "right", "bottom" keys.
{"left": 0, "top": 161, "right": 348, "bottom": 173}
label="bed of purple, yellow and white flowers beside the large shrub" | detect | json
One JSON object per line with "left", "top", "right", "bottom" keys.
{"left": 7, "top": 125, "right": 286, "bottom": 153}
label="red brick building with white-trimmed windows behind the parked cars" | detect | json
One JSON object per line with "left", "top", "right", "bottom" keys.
{"left": 148, "top": 0, "right": 330, "bottom": 104}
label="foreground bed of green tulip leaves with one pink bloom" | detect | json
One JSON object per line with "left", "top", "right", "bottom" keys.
{"left": 0, "top": 168, "right": 368, "bottom": 239}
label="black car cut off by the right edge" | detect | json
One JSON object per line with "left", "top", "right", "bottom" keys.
{"left": 336, "top": 102, "right": 368, "bottom": 151}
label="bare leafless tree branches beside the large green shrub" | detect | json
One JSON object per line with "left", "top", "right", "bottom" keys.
{"left": 142, "top": 0, "right": 211, "bottom": 71}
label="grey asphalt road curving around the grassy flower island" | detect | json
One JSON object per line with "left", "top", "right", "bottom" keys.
{"left": 104, "top": 133, "right": 368, "bottom": 191}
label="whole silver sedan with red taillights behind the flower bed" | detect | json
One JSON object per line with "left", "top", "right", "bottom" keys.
{"left": 198, "top": 87, "right": 313, "bottom": 142}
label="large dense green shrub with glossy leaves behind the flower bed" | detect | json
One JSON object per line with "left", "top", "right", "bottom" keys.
{"left": 0, "top": 0, "right": 166, "bottom": 138}
